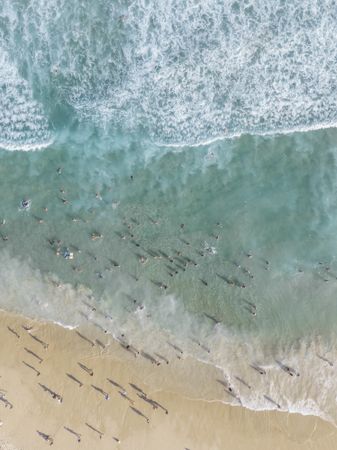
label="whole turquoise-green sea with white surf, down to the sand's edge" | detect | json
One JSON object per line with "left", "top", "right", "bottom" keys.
{"left": 0, "top": 0, "right": 337, "bottom": 423}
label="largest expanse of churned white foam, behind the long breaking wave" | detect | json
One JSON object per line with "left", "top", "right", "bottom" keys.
{"left": 0, "top": 0, "right": 337, "bottom": 145}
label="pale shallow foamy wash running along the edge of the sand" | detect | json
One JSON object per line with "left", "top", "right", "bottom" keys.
{"left": 0, "top": 252, "right": 337, "bottom": 423}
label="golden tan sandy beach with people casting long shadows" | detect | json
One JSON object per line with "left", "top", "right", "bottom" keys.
{"left": 0, "top": 312, "right": 337, "bottom": 450}
